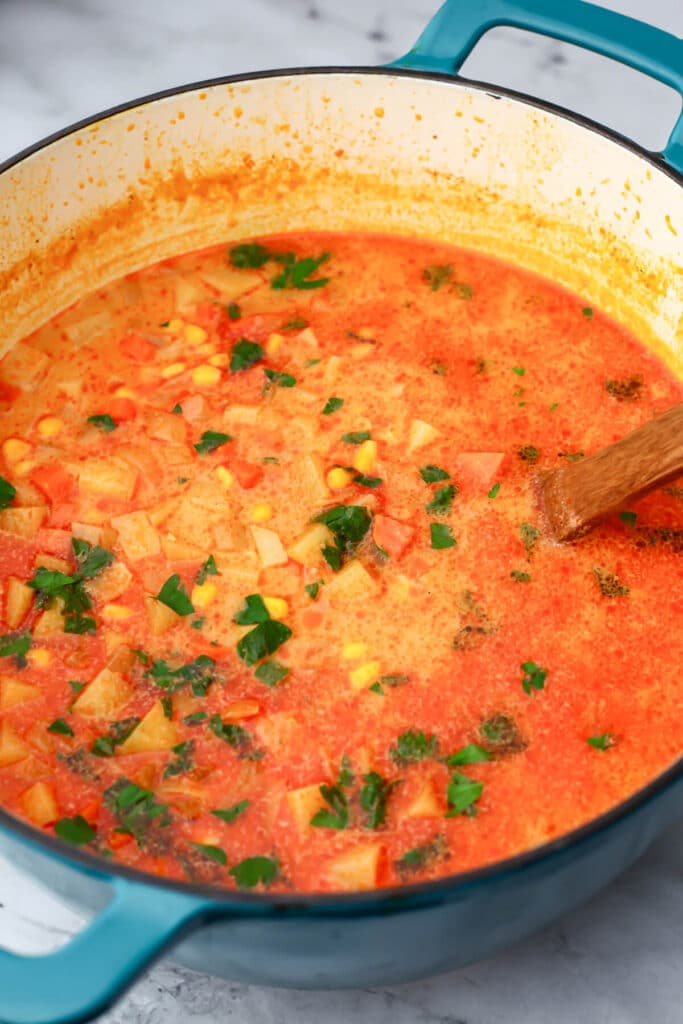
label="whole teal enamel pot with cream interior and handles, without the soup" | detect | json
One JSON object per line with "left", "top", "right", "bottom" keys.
{"left": 0, "top": 0, "right": 683, "bottom": 1024}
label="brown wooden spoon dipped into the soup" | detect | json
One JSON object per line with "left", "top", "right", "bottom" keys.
{"left": 540, "top": 402, "right": 683, "bottom": 541}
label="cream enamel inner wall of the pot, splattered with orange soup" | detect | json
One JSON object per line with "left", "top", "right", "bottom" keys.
{"left": 0, "top": 72, "right": 683, "bottom": 373}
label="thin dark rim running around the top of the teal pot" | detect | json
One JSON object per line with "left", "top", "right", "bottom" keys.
{"left": 0, "top": 65, "right": 683, "bottom": 915}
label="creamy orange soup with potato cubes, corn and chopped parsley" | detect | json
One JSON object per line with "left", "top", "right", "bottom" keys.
{"left": 0, "top": 233, "right": 683, "bottom": 892}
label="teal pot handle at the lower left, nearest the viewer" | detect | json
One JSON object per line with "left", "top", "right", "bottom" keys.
{"left": 0, "top": 879, "right": 213, "bottom": 1024}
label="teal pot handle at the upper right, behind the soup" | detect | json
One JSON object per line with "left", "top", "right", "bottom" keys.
{"left": 391, "top": 0, "right": 683, "bottom": 173}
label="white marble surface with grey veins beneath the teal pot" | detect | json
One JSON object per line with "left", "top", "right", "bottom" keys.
{"left": 0, "top": 0, "right": 683, "bottom": 1024}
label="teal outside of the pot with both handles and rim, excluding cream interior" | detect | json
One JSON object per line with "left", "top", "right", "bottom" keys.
{"left": 0, "top": 0, "right": 683, "bottom": 1024}
